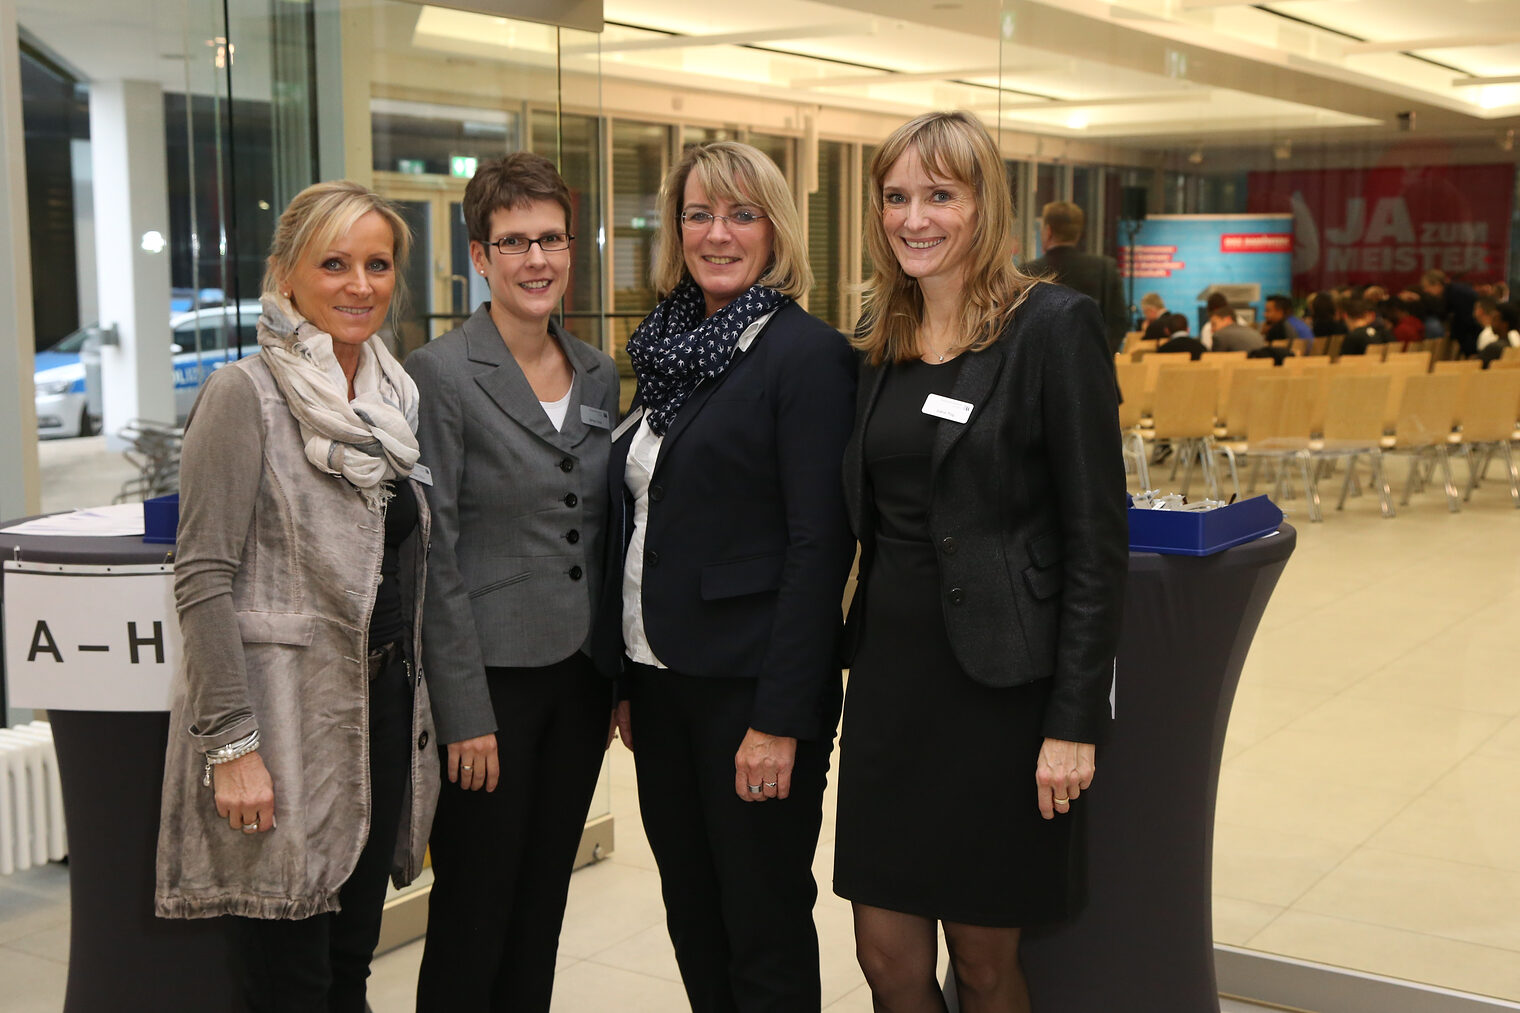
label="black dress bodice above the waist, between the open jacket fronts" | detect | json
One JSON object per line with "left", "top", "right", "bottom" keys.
{"left": 865, "top": 356, "right": 965, "bottom": 541}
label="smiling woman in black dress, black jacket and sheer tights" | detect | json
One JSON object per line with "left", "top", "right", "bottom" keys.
{"left": 834, "top": 113, "right": 1128, "bottom": 1013}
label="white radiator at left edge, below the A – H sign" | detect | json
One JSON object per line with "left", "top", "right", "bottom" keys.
{"left": 0, "top": 721, "right": 68, "bottom": 875}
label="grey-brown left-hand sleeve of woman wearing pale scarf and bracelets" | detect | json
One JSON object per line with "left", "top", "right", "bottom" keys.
{"left": 175, "top": 368, "right": 264, "bottom": 750}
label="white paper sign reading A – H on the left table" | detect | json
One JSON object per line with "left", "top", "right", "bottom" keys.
{"left": 3, "top": 560, "right": 181, "bottom": 710}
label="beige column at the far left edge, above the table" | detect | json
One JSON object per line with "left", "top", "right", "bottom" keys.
{"left": 0, "top": 0, "right": 41, "bottom": 520}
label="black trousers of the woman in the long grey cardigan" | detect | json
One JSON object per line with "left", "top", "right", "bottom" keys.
{"left": 233, "top": 649, "right": 412, "bottom": 1013}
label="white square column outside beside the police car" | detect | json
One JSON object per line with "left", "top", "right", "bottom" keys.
{"left": 90, "top": 81, "right": 175, "bottom": 450}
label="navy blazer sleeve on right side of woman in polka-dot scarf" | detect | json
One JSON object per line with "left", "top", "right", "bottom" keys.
{"left": 749, "top": 329, "right": 856, "bottom": 738}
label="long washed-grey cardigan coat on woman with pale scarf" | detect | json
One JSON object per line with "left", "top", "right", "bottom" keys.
{"left": 154, "top": 356, "right": 438, "bottom": 919}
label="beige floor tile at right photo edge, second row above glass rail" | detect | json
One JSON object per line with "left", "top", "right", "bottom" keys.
{"left": 1292, "top": 847, "right": 1520, "bottom": 963}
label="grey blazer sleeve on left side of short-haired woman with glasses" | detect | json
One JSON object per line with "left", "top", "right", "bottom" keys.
{"left": 406, "top": 345, "right": 496, "bottom": 742}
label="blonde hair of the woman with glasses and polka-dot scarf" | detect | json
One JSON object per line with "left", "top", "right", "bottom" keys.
{"left": 649, "top": 141, "right": 813, "bottom": 300}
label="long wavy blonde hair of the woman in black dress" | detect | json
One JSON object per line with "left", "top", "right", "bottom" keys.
{"left": 851, "top": 111, "right": 1035, "bottom": 364}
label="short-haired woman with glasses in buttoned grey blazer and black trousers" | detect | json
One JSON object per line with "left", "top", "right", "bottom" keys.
{"left": 406, "top": 152, "right": 617, "bottom": 1013}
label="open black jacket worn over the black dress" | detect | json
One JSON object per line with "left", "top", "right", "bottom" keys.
{"left": 845, "top": 284, "right": 1129, "bottom": 742}
